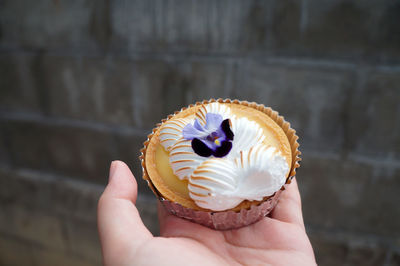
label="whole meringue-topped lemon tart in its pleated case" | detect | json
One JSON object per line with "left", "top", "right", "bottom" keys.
{"left": 141, "top": 99, "right": 300, "bottom": 229}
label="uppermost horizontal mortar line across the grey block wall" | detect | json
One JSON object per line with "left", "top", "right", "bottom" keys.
{"left": 0, "top": 46, "right": 400, "bottom": 73}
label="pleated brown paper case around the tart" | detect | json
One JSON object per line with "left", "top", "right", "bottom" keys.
{"left": 139, "top": 99, "right": 301, "bottom": 230}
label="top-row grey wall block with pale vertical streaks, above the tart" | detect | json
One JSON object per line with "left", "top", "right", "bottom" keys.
{"left": 111, "top": 0, "right": 271, "bottom": 53}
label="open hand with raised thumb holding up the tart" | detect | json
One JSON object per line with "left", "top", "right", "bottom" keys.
{"left": 98, "top": 161, "right": 315, "bottom": 266}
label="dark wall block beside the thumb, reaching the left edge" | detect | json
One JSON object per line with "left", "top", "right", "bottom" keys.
{"left": 0, "top": 169, "right": 104, "bottom": 221}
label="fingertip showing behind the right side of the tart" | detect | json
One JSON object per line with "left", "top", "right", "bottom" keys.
{"left": 270, "top": 178, "right": 304, "bottom": 228}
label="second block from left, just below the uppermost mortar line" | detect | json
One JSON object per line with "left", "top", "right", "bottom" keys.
{"left": 42, "top": 56, "right": 136, "bottom": 125}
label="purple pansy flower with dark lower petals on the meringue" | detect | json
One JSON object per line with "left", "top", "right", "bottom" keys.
{"left": 182, "top": 113, "right": 233, "bottom": 157}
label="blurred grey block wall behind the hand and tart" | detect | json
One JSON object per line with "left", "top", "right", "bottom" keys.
{"left": 0, "top": 0, "right": 400, "bottom": 266}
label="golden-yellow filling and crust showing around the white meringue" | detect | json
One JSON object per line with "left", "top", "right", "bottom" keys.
{"left": 153, "top": 105, "right": 292, "bottom": 209}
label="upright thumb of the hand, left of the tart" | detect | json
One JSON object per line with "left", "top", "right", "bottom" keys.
{"left": 97, "top": 161, "right": 152, "bottom": 265}
